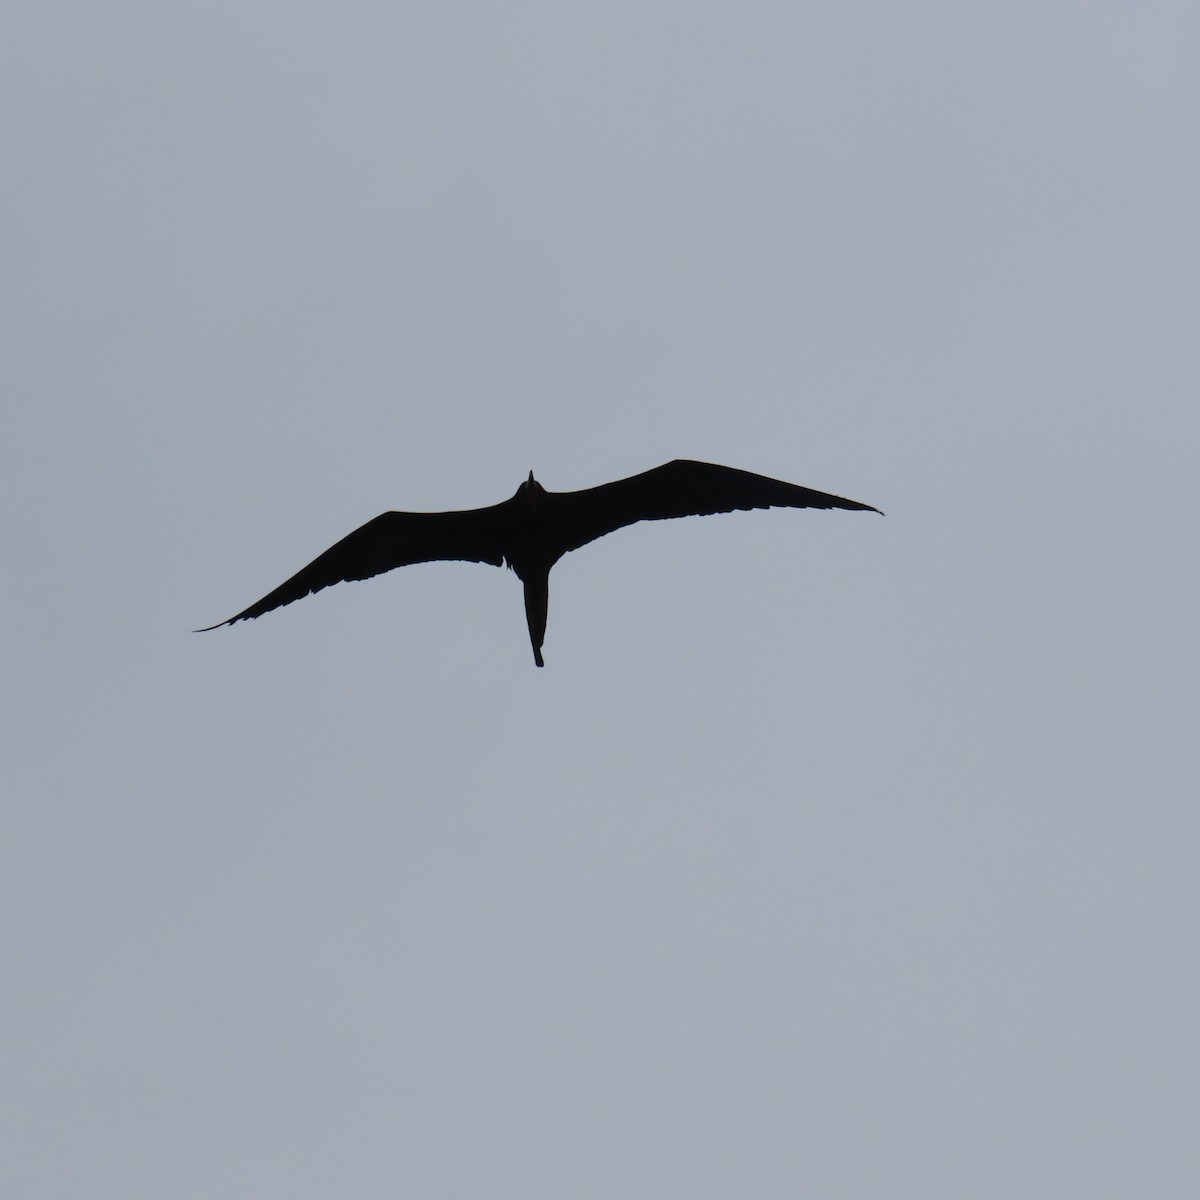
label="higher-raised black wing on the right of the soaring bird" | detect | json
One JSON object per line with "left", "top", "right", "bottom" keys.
{"left": 554, "top": 458, "right": 880, "bottom": 554}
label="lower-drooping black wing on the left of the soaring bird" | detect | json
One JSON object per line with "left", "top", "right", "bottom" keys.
{"left": 197, "top": 504, "right": 504, "bottom": 634}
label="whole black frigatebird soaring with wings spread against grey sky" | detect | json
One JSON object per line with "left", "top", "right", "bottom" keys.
{"left": 196, "top": 458, "right": 881, "bottom": 667}
